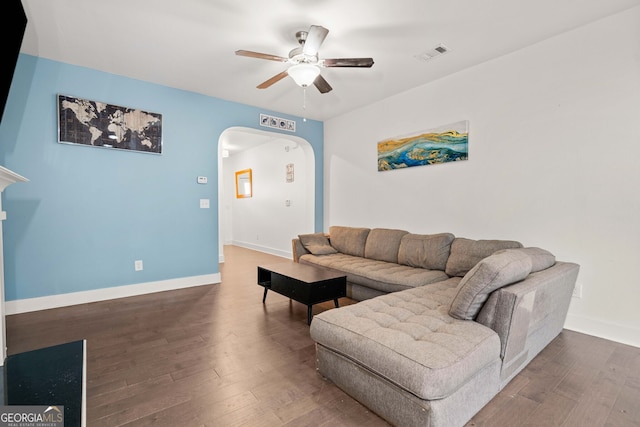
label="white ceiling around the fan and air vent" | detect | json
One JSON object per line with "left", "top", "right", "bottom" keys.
{"left": 17, "top": 0, "right": 640, "bottom": 120}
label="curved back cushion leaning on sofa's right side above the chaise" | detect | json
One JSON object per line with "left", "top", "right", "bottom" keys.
{"left": 449, "top": 250, "right": 532, "bottom": 320}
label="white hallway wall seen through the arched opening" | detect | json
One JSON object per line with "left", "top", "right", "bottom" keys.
{"left": 223, "top": 138, "right": 315, "bottom": 258}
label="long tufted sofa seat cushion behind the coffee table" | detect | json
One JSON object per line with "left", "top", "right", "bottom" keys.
{"left": 299, "top": 253, "right": 448, "bottom": 292}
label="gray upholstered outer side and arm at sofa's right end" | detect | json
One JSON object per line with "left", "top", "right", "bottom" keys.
{"left": 476, "top": 262, "right": 579, "bottom": 385}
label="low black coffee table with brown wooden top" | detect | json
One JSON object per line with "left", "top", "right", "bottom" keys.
{"left": 258, "top": 261, "right": 347, "bottom": 325}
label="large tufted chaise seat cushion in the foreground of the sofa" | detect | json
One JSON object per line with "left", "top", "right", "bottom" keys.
{"left": 310, "top": 278, "right": 500, "bottom": 400}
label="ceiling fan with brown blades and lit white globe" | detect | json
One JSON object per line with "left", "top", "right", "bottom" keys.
{"left": 236, "top": 25, "right": 373, "bottom": 93}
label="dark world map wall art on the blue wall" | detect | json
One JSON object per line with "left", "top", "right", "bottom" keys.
{"left": 58, "top": 95, "right": 162, "bottom": 154}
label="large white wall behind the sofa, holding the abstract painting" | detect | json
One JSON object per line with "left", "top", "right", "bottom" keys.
{"left": 324, "top": 8, "right": 640, "bottom": 346}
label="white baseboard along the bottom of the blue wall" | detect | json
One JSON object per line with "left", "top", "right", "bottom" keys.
{"left": 5, "top": 273, "right": 221, "bottom": 315}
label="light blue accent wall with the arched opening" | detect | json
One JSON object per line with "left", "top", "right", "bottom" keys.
{"left": 0, "top": 54, "right": 323, "bottom": 301}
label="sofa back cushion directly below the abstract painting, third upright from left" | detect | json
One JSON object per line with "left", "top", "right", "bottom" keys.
{"left": 398, "top": 233, "right": 455, "bottom": 271}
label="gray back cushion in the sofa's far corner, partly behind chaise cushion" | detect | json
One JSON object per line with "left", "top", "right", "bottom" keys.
{"left": 445, "top": 237, "right": 522, "bottom": 277}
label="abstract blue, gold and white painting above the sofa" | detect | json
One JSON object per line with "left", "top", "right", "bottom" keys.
{"left": 378, "top": 120, "right": 469, "bottom": 171}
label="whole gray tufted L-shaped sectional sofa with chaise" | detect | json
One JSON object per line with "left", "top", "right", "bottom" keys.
{"left": 293, "top": 226, "right": 579, "bottom": 427}
